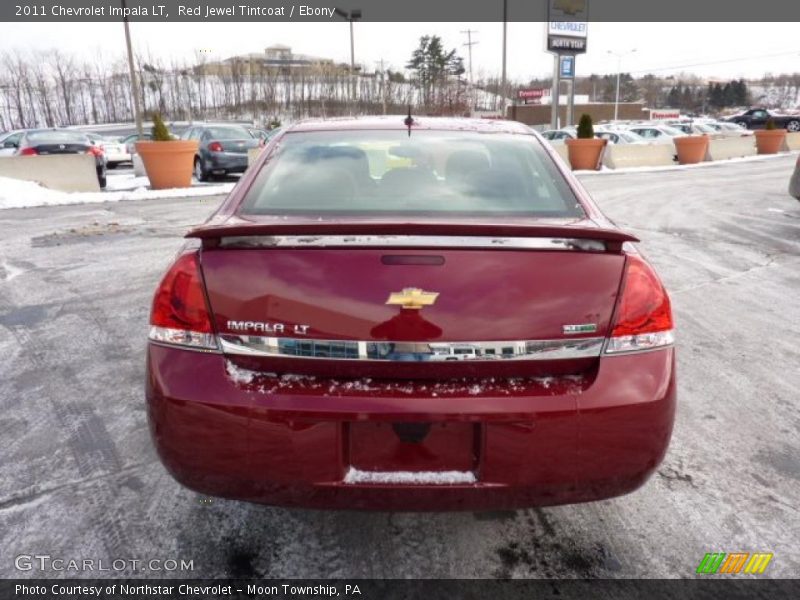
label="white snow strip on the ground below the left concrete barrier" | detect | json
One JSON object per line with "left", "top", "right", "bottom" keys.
{"left": 0, "top": 177, "right": 235, "bottom": 210}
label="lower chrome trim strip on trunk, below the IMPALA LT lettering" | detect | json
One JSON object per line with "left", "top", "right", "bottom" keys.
{"left": 218, "top": 333, "right": 605, "bottom": 362}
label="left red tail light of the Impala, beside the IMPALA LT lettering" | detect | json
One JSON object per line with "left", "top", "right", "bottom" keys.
{"left": 150, "top": 252, "right": 217, "bottom": 350}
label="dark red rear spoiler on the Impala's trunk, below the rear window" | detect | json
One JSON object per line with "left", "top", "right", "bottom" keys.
{"left": 186, "top": 217, "right": 639, "bottom": 252}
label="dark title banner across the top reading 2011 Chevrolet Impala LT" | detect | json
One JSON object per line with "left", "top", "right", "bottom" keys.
{"left": 0, "top": 0, "right": 800, "bottom": 22}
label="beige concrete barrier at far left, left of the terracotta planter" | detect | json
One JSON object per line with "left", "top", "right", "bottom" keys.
{"left": 0, "top": 154, "right": 100, "bottom": 192}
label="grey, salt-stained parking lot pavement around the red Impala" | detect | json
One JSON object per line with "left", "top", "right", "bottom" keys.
{"left": 0, "top": 156, "right": 800, "bottom": 577}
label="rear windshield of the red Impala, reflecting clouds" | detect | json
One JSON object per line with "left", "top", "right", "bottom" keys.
{"left": 239, "top": 131, "right": 584, "bottom": 217}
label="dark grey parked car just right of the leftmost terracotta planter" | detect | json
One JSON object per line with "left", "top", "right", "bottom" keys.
{"left": 181, "top": 123, "right": 260, "bottom": 181}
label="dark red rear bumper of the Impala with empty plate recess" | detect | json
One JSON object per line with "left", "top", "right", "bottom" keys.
{"left": 146, "top": 343, "right": 676, "bottom": 510}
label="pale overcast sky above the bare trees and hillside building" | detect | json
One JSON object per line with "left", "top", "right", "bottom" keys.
{"left": 0, "top": 21, "right": 800, "bottom": 80}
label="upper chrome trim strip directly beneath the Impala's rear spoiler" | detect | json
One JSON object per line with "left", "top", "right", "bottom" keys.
{"left": 220, "top": 235, "right": 606, "bottom": 252}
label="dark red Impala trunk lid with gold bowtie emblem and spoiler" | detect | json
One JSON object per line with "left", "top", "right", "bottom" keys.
{"left": 190, "top": 218, "right": 635, "bottom": 378}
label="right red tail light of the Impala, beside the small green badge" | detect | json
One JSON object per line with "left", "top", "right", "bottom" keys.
{"left": 606, "top": 255, "right": 675, "bottom": 354}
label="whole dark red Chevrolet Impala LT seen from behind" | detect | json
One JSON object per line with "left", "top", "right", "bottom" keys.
{"left": 146, "top": 116, "right": 676, "bottom": 510}
